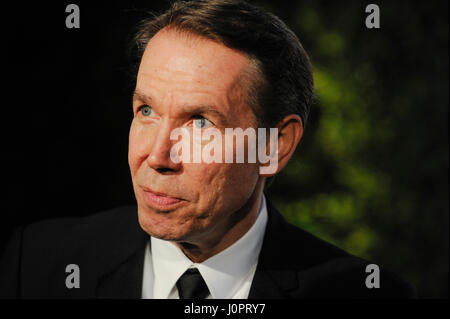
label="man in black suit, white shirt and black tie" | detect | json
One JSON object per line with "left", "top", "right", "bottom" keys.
{"left": 0, "top": 0, "right": 412, "bottom": 299}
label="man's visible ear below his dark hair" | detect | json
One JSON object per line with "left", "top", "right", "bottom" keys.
{"left": 261, "top": 114, "right": 303, "bottom": 177}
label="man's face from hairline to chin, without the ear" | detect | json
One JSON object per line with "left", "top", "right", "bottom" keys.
{"left": 128, "top": 30, "right": 260, "bottom": 242}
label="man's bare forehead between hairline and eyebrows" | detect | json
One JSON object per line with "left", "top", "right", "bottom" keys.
{"left": 137, "top": 29, "right": 250, "bottom": 102}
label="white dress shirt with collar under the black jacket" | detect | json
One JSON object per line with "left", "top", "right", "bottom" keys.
{"left": 142, "top": 194, "right": 267, "bottom": 299}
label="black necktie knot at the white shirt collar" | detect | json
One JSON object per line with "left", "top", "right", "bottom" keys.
{"left": 177, "top": 268, "right": 209, "bottom": 299}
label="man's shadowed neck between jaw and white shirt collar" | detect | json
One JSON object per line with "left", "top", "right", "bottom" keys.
{"left": 174, "top": 181, "right": 264, "bottom": 263}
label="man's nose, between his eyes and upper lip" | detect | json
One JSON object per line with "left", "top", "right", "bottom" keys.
{"left": 147, "top": 125, "right": 181, "bottom": 174}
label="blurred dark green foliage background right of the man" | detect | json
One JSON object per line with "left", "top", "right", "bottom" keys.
{"left": 253, "top": 0, "right": 449, "bottom": 297}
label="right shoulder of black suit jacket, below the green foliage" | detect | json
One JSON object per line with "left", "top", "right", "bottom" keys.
{"left": 259, "top": 201, "right": 416, "bottom": 298}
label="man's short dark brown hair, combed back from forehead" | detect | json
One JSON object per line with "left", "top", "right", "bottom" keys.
{"left": 133, "top": 0, "right": 314, "bottom": 127}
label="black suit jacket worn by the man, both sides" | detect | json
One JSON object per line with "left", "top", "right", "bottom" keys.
{"left": 0, "top": 201, "right": 415, "bottom": 299}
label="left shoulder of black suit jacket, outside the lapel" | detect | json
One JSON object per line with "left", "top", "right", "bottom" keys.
{"left": 0, "top": 206, "right": 145, "bottom": 298}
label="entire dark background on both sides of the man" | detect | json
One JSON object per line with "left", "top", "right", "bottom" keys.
{"left": 0, "top": 0, "right": 449, "bottom": 298}
